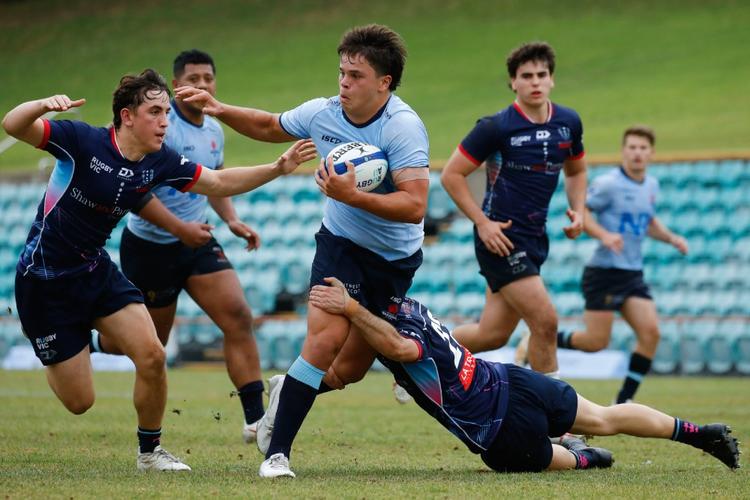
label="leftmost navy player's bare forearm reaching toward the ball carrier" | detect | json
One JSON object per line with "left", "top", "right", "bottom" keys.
{"left": 190, "top": 139, "right": 317, "bottom": 196}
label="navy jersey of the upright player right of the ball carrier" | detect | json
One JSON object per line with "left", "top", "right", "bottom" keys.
{"left": 459, "top": 102, "right": 584, "bottom": 236}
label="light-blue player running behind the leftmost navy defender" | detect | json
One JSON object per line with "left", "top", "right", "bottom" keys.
{"left": 92, "top": 50, "right": 263, "bottom": 443}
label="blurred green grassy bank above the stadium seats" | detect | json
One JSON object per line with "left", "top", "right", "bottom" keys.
{"left": 0, "top": 0, "right": 750, "bottom": 172}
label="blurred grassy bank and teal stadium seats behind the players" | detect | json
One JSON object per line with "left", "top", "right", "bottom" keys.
{"left": 0, "top": 0, "right": 750, "bottom": 376}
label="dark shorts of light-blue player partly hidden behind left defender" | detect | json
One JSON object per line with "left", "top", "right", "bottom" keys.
{"left": 120, "top": 228, "right": 232, "bottom": 307}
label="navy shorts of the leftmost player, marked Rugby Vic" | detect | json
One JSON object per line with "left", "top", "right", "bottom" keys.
{"left": 16, "top": 254, "right": 143, "bottom": 365}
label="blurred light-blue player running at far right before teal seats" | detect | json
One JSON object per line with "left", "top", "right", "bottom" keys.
{"left": 516, "top": 126, "right": 688, "bottom": 403}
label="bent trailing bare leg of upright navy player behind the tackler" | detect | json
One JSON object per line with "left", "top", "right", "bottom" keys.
{"left": 452, "top": 287, "right": 521, "bottom": 353}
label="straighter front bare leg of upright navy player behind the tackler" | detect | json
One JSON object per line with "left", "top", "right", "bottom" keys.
{"left": 500, "top": 276, "right": 558, "bottom": 374}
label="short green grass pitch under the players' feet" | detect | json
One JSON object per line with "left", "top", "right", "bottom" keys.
{"left": 0, "top": 367, "right": 750, "bottom": 498}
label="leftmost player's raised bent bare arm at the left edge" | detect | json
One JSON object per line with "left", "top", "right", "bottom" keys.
{"left": 3, "top": 95, "right": 86, "bottom": 147}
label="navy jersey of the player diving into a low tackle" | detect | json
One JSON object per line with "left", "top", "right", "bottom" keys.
{"left": 378, "top": 297, "right": 508, "bottom": 453}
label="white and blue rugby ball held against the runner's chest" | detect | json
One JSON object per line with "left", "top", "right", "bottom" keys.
{"left": 326, "top": 142, "right": 388, "bottom": 191}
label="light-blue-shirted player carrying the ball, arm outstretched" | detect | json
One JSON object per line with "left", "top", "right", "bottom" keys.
{"left": 176, "top": 25, "right": 429, "bottom": 476}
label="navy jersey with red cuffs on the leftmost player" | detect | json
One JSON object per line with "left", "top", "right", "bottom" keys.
{"left": 17, "top": 120, "right": 202, "bottom": 279}
